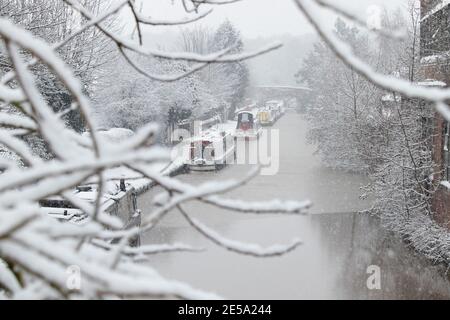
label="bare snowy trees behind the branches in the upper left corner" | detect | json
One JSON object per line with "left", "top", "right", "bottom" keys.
{"left": 0, "top": 0, "right": 114, "bottom": 131}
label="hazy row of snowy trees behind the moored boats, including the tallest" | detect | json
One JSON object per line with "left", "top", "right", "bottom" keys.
{"left": 94, "top": 21, "right": 248, "bottom": 140}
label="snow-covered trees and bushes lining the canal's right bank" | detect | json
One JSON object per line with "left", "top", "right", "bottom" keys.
{"left": 297, "top": 2, "right": 450, "bottom": 263}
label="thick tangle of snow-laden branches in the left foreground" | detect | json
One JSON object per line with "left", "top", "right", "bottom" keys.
{"left": 0, "top": 0, "right": 310, "bottom": 299}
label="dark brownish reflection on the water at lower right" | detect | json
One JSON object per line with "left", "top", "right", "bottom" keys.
{"left": 313, "top": 214, "right": 450, "bottom": 299}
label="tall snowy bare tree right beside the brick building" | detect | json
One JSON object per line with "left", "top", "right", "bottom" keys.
{"left": 367, "top": 2, "right": 445, "bottom": 260}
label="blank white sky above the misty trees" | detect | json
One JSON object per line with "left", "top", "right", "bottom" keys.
{"left": 132, "top": 0, "right": 409, "bottom": 38}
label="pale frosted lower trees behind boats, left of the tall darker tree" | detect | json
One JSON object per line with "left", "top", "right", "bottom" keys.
{"left": 94, "top": 54, "right": 217, "bottom": 141}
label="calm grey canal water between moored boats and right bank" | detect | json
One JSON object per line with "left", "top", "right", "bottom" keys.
{"left": 138, "top": 113, "right": 450, "bottom": 299}
